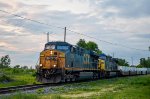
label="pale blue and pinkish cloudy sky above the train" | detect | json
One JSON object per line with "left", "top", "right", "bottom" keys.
{"left": 0, "top": 0, "right": 150, "bottom": 68}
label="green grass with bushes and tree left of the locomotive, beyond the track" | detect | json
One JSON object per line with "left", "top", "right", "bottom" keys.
{"left": 0, "top": 55, "right": 38, "bottom": 88}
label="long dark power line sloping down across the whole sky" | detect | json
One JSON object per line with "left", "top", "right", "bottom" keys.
{"left": 0, "top": 10, "right": 148, "bottom": 51}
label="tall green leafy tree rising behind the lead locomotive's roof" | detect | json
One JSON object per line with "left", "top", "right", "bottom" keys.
{"left": 77, "top": 39, "right": 102, "bottom": 54}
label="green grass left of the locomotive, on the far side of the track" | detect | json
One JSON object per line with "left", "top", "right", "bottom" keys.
{"left": 0, "top": 68, "right": 38, "bottom": 88}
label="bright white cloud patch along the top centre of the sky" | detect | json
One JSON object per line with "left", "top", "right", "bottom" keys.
{"left": 20, "top": 0, "right": 91, "bottom": 14}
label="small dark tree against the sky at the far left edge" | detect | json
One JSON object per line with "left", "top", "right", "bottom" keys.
{"left": 0, "top": 55, "right": 11, "bottom": 68}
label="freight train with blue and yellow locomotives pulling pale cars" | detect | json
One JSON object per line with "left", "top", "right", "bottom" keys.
{"left": 36, "top": 41, "right": 150, "bottom": 83}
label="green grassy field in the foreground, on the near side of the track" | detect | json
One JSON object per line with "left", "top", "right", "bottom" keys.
{"left": 1, "top": 75, "right": 150, "bottom": 99}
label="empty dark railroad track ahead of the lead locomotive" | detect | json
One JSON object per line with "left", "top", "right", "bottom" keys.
{"left": 0, "top": 83, "right": 61, "bottom": 94}
